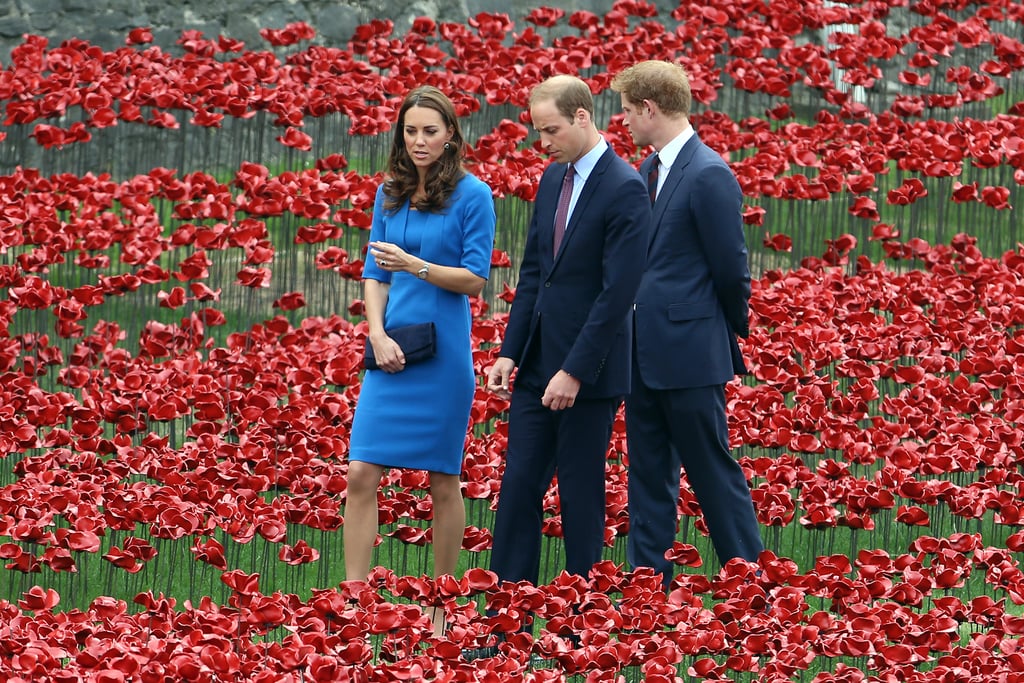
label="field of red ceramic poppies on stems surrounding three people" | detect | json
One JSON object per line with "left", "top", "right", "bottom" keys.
{"left": 0, "top": 0, "right": 1024, "bottom": 683}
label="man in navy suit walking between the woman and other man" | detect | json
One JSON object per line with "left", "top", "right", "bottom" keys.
{"left": 487, "top": 75, "right": 651, "bottom": 602}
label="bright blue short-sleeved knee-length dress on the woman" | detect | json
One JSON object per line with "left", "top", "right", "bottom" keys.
{"left": 349, "top": 173, "right": 496, "bottom": 474}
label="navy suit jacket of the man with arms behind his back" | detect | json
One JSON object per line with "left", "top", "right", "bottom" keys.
{"left": 634, "top": 135, "right": 751, "bottom": 389}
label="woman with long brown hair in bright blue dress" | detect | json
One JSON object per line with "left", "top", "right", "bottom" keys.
{"left": 343, "top": 86, "right": 496, "bottom": 636}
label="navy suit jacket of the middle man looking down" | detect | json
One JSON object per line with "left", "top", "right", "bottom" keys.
{"left": 500, "top": 146, "right": 650, "bottom": 398}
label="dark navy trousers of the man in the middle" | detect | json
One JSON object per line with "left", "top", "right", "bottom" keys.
{"left": 490, "top": 383, "right": 622, "bottom": 585}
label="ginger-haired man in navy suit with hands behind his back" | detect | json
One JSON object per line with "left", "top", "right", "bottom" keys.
{"left": 611, "top": 60, "right": 764, "bottom": 589}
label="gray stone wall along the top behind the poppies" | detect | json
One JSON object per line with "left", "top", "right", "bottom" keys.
{"left": 0, "top": 0, "right": 663, "bottom": 57}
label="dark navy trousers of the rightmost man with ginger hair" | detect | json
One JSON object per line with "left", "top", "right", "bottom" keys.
{"left": 626, "top": 378, "right": 764, "bottom": 589}
